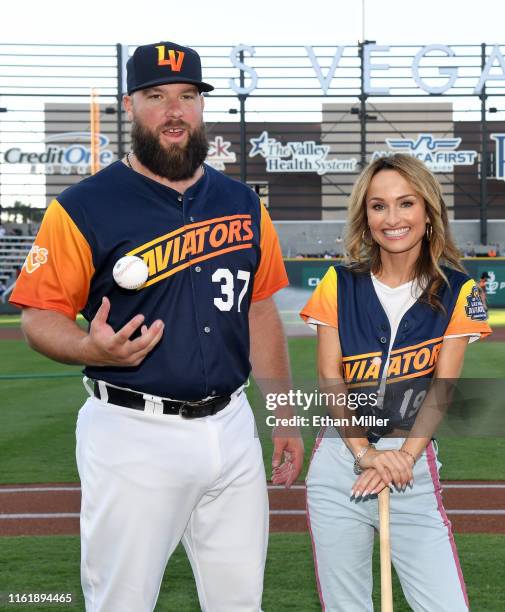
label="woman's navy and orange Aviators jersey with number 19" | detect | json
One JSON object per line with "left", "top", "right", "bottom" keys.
{"left": 300, "top": 266, "right": 491, "bottom": 433}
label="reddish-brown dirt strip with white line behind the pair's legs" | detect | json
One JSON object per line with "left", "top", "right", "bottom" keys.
{"left": 0, "top": 481, "right": 505, "bottom": 536}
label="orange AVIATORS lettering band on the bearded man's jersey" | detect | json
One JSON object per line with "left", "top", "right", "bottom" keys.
{"left": 127, "top": 215, "right": 253, "bottom": 287}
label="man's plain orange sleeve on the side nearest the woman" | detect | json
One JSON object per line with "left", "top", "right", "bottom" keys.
{"left": 252, "top": 203, "right": 289, "bottom": 302}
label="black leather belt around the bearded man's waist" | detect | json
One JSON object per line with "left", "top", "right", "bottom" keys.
{"left": 93, "top": 380, "right": 231, "bottom": 419}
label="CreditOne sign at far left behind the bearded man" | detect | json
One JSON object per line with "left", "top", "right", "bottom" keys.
{"left": 3, "top": 132, "right": 114, "bottom": 174}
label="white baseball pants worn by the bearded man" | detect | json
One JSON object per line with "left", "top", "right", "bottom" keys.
{"left": 76, "top": 393, "right": 268, "bottom": 612}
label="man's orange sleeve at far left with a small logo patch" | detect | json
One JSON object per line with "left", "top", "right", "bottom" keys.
{"left": 9, "top": 200, "right": 95, "bottom": 319}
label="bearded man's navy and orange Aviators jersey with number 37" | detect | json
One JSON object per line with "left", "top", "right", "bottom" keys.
{"left": 11, "top": 162, "right": 288, "bottom": 400}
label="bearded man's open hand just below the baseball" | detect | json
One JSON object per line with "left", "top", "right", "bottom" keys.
{"left": 81, "top": 297, "right": 164, "bottom": 367}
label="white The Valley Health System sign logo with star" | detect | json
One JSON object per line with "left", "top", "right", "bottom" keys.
{"left": 249, "top": 130, "right": 358, "bottom": 175}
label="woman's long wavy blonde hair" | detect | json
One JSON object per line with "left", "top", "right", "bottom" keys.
{"left": 345, "top": 154, "right": 464, "bottom": 309}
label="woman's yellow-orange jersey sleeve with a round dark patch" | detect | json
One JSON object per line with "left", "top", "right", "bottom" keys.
{"left": 444, "top": 279, "right": 492, "bottom": 338}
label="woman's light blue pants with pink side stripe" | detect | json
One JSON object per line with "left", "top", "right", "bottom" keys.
{"left": 307, "top": 428, "right": 468, "bottom": 612}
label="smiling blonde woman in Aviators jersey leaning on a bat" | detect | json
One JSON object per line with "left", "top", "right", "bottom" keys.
{"left": 301, "top": 155, "right": 491, "bottom": 612}
